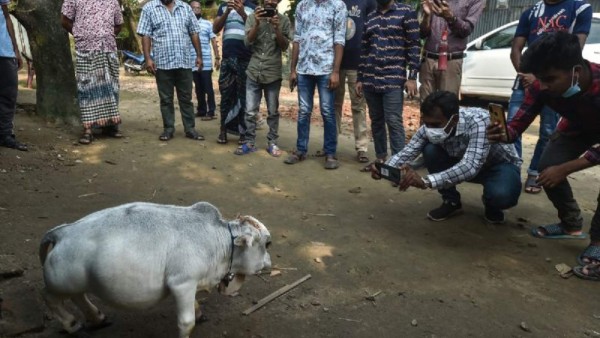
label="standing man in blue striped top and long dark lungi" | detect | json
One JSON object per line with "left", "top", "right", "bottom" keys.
{"left": 213, "top": 0, "right": 256, "bottom": 144}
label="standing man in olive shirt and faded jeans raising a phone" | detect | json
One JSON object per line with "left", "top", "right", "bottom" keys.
{"left": 235, "top": 0, "right": 292, "bottom": 157}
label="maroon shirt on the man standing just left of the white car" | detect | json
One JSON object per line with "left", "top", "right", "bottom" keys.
{"left": 421, "top": 0, "right": 486, "bottom": 53}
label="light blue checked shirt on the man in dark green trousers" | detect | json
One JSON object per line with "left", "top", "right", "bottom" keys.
{"left": 137, "top": 0, "right": 200, "bottom": 69}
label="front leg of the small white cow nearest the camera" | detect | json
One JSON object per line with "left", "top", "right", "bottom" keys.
{"left": 169, "top": 282, "right": 196, "bottom": 338}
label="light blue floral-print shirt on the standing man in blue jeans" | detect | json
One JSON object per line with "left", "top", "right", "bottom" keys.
{"left": 294, "top": 0, "right": 348, "bottom": 75}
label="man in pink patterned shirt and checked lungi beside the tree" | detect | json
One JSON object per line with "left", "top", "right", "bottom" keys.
{"left": 61, "top": 0, "right": 123, "bottom": 144}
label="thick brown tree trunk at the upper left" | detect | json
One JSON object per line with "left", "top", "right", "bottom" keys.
{"left": 14, "top": 0, "right": 79, "bottom": 123}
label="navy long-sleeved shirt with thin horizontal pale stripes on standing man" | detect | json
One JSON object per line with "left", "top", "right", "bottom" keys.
{"left": 358, "top": 2, "right": 421, "bottom": 93}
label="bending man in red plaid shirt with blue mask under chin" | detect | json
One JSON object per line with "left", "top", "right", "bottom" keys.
{"left": 488, "top": 32, "right": 600, "bottom": 280}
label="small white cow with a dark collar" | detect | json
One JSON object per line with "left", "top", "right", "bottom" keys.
{"left": 40, "top": 202, "right": 271, "bottom": 337}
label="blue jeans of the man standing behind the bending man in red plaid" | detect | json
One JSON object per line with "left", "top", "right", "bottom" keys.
{"left": 508, "top": 89, "right": 560, "bottom": 176}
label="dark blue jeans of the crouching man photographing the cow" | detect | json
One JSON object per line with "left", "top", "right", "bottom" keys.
{"left": 423, "top": 143, "right": 521, "bottom": 211}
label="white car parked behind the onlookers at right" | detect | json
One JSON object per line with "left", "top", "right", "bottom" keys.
{"left": 460, "top": 13, "right": 600, "bottom": 100}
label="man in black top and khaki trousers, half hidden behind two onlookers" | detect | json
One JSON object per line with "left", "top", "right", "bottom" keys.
{"left": 335, "top": 0, "right": 377, "bottom": 163}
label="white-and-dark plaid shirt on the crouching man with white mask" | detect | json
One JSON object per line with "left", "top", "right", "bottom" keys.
{"left": 387, "top": 108, "right": 522, "bottom": 189}
